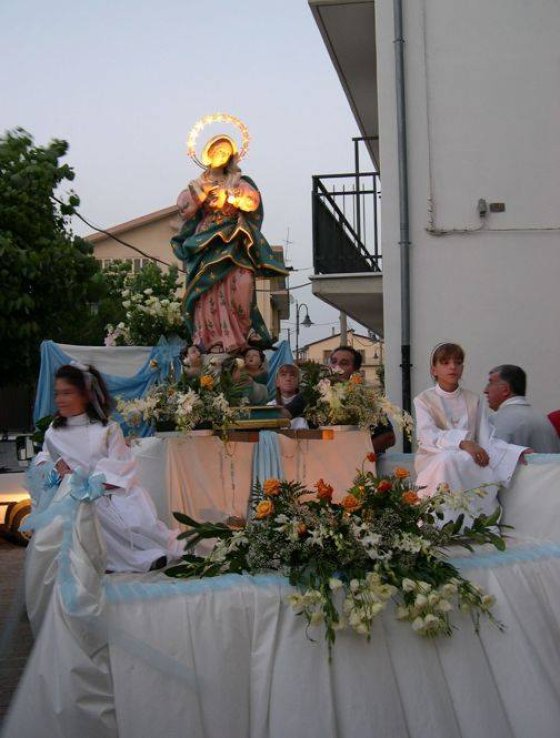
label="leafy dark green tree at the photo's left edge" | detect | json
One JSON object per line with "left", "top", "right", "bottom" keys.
{"left": 0, "top": 128, "right": 101, "bottom": 386}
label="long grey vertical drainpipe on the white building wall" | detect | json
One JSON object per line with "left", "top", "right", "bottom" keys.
{"left": 393, "top": 0, "right": 412, "bottom": 453}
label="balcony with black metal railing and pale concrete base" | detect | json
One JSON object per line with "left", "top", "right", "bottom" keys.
{"left": 311, "top": 158, "right": 383, "bottom": 335}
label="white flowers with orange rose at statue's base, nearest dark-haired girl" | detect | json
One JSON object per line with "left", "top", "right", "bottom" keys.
{"left": 117, "top": 370, "right": 248, "bottom": 435}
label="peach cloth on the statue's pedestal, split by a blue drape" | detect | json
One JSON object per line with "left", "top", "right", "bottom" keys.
{"left": 133, "top": 431, "right": 374, "bottom": 525}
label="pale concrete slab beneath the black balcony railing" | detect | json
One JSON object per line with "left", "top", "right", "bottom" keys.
{"left": 309, "top": 272, "right": 383, "bottom": 335}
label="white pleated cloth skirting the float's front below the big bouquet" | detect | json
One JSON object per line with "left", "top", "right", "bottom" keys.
{"left": 103, "top": 549, "right": 560, "bottom": 738}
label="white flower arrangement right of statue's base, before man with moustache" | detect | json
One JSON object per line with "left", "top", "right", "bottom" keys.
{"left": 301, "top": 362, "right": 413, "bottom": 437}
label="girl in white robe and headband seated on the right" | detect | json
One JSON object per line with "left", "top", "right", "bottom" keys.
{"left": 414, "top": 343, "right": 528, "bottom": 524}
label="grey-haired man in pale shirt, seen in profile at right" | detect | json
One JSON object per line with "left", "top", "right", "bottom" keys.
{"left": 484, "top": 364, "right": 560, "bottom": 454}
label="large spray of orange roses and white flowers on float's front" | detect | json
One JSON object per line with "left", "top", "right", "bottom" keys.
{"left": 166, "top": 454, "right": 504, "bottom": 649}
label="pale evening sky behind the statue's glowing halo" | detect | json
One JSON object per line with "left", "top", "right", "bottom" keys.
{"left": 0, "top": 0, "right": 372, "bottom": 345}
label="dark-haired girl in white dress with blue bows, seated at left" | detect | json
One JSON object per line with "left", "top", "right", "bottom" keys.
{"left": 33, "top": 362, "right": 183, "bottom": 572}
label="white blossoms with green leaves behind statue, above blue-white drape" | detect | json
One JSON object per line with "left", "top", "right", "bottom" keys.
{"left": 105, "top": 264, "right": 190, "bottom": 346}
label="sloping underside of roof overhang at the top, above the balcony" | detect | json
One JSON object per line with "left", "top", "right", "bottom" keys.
{"left": 308, "top": 0, "right": 379, "bottom": 171}
